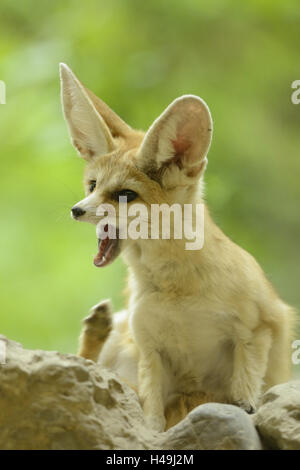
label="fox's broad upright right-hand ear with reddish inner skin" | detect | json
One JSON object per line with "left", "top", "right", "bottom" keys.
{"left": 138, "top": 95, "right": 212, "bottom": 183}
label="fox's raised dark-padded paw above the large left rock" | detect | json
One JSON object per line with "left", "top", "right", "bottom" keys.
{"left": 82, "top": 300, "right": 112, "bottom": 339}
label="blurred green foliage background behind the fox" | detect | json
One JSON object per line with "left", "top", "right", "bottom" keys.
{"left": 0, "top": 0, "right": 300, "bottom": 364}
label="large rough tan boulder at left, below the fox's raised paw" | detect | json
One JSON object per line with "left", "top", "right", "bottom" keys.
{"left": 0, "top": 336, "right": 155, "bottom": 449}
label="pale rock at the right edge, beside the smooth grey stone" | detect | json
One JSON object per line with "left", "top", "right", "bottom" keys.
{"left": 254, "top": 380, "right": 300, "bottom": 450}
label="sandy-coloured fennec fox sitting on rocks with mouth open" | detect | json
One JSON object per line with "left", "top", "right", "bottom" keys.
{"left": 60, "top": 64, "right": 294, "bottom": 431}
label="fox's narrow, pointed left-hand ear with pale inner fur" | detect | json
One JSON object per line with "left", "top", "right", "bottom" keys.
{"left": 60, "top": 64, "right": 114, "bottom": 160}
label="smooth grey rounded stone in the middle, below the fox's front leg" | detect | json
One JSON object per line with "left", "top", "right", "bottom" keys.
{"left": 162, "top": 403, "right": 262, "bottom": 450}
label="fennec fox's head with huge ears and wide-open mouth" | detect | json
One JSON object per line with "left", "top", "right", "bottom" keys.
{"left": 60, "top": 64, "right": 212, "bottom": 266}
